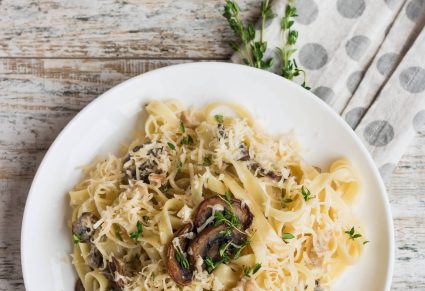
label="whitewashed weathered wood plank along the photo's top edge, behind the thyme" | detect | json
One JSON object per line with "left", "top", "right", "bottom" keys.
{"left": 0, "top": 0, "right": 261, "bottom": 59}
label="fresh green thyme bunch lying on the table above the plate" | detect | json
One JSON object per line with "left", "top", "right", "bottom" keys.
{"left": 223, "top": 0, "right": 310, "bottom": 90}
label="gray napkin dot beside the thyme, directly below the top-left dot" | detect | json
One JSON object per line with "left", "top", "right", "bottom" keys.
{"left": 298, "top": 43, "right": 328, "bottom": 70}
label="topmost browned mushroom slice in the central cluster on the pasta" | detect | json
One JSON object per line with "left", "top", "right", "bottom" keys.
{"left": 193, "top": 196, "right": 253, "bottom": 230}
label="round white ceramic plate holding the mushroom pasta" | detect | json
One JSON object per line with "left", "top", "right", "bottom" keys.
{"left": 21, "top": 63, "right": 394, "bottom": 291}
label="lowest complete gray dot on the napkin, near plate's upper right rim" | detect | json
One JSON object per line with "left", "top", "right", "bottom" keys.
{"left": 363, "top": 120, "right": 394, "bottom": 147}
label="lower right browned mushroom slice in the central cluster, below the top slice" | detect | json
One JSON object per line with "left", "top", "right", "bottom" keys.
{"left": 189, "top": 224, "right": 247, "bottom": 269}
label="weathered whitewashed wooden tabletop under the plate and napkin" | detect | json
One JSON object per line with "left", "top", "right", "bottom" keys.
{"left": 0, "top": 0, "right": 425, "bottom": 291}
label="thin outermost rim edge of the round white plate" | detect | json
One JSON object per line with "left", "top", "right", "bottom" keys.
{"left": 20, "top": 61, "right": 395, "bottom": 290}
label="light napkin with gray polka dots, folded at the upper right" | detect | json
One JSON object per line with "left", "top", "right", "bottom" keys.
{"left": 232, "top": 0, "right": 425, "bottom": 185}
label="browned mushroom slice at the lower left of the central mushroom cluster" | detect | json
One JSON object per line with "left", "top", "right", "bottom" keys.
{"left": 166, "top": 224, "right": 193, "bottom": 285}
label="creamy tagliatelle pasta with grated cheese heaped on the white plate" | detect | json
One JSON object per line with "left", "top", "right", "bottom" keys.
{"left": 69, "top": 101, "right": 365, "bottom": 291}
